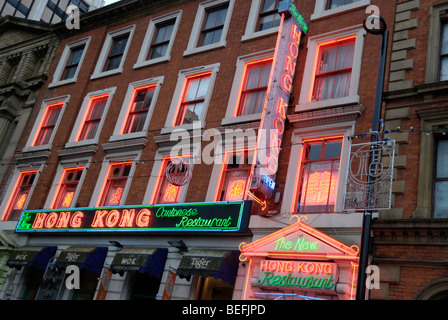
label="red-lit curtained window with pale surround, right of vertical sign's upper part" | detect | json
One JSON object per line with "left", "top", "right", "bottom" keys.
{"left": 295, "top": 25, "right": 364, "bottom": 112}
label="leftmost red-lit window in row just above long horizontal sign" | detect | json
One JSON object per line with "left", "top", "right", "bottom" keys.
{"left": 2, "top": 170, "right": 37, "bottom": 221}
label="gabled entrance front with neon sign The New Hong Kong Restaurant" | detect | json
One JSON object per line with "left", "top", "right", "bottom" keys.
{"left": 240, "top": 216, "right": 359, "bottom": 300}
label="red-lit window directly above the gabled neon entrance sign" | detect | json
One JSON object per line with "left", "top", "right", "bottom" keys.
{"left": 297, "top": 138, "right": 342, "bottom": 213}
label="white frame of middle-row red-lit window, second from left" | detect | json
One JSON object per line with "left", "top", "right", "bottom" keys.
{"left": 65, "top": 87, "right": 117, "bottom": 148}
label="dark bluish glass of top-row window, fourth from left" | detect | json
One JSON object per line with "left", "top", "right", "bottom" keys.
{"left": 198, "top": 4, "right": 229, "bottom": 47}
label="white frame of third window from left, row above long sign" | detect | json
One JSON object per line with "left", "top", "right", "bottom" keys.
{"left": 89, "top": 150, "right": 142, "bottom": 207}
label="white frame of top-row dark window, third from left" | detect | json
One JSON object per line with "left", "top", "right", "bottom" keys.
{"left": 134, "top": 10, "right": 182, "bottom": 69}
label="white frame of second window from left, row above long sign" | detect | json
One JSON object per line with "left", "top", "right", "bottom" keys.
{"left": 44, "top": 157, "right": 91, "bottom": 209}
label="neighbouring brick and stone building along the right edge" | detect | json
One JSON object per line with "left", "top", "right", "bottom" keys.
{"left": 371, "top": 0, "right": 448, "bottom": 300}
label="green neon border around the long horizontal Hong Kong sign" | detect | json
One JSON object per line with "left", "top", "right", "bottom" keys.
{"left": 15, "top": 200, "right": 250, "bottom": 233}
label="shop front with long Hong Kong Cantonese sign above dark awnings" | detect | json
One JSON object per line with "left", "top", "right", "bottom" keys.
{"left": 3, "top": 201, "right": 251, "bottom": 300}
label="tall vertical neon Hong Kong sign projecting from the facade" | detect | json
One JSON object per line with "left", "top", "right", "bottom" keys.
{"left": 250, "top": 0, "right": 308, "bottom": 202}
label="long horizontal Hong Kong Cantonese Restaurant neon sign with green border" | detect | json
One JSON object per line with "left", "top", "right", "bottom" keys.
{"left": 16, "top": 201, "right": 251, "bottom": 233}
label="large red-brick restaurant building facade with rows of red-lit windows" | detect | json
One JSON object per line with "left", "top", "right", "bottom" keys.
{"left": 0, "top": 0, "right": 410, "bottom": 300}
